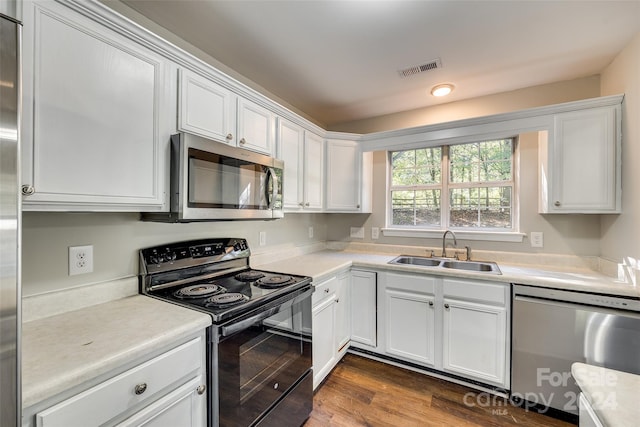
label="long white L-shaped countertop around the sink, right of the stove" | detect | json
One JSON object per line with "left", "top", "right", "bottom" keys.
{"left": 252, "top": 250, "right": 640, "bottom": 297}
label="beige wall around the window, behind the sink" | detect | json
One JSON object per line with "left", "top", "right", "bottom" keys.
{"left": 327, "top": 132, "right": 600, "bottom": 256}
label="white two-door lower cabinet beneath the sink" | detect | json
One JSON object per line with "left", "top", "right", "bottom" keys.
{"left": 378, "top": 272, "right": 510, "bottom": 388}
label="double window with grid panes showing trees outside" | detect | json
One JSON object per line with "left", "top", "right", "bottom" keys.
{"left": 389, "top": 138, "right": 516, "bottom": 232}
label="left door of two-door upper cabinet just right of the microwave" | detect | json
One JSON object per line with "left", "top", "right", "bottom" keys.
{"left": 277, "top": 119, "right": 304, "bottom": 211}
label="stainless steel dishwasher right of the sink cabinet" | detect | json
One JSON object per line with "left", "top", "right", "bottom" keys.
{"left": 511, "top": 285, "right": 640, "bottom": 414}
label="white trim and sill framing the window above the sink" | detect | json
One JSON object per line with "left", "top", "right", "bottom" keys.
{"left": 381, "top": 135, "right": 527, "bottom": 243}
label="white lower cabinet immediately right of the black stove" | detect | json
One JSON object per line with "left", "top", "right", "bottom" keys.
{"left": 312, "top": 272, "right": 351, "bottom": 389}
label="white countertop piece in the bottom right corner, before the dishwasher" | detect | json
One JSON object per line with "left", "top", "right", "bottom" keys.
{"left": 571, "top": 363, "right": 640, "bottom": 427}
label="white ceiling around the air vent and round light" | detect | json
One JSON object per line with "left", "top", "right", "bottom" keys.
{"left": 123, "top": 0, "right": 640, "bottom": 126}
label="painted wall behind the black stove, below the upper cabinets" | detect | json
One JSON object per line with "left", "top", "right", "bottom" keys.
{"left": 22, "top": 212, "right": 326, "bottom": 296}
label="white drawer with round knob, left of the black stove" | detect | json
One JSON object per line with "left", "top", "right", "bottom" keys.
{"left": 36, "top": 338, "right": 202, "bottom": 427}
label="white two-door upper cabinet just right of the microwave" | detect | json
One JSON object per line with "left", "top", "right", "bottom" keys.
{"left": 277, "top": 118, "right": 324, "bottom": 212}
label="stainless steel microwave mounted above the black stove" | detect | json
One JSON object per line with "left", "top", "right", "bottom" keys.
{"left": 142, "top": 133, "right": 284, "bottom": 222}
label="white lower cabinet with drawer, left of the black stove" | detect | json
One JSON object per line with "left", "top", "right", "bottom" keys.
{"left": 29, "top": 335, "right": 207, "bottom": 427}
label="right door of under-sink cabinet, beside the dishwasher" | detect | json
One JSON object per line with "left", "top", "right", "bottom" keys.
{"left": 442, "top": 298, "right": 507, "bottom": 385}
